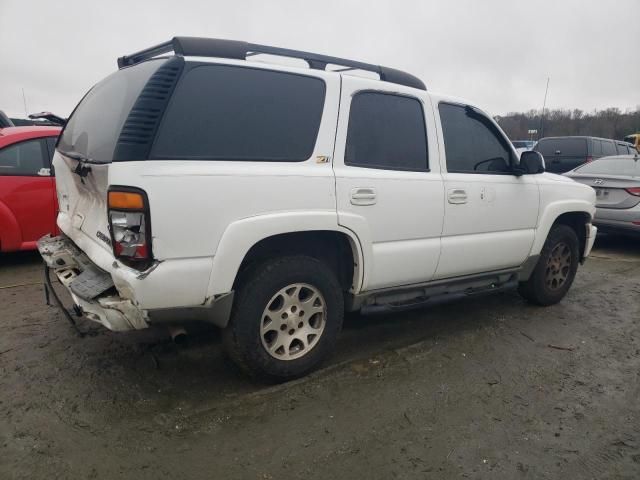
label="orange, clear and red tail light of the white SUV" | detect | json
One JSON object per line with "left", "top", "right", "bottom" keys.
{"left": 108, "top": 187, "right": 153, "bottom": 268}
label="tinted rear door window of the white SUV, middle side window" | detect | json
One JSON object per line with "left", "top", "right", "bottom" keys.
{"left": 345, "top": 92, "right": 429, "bottom": 171}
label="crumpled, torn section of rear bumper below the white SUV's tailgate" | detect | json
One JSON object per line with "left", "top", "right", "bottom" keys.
{"left": 37, "top": 235, "right": 149, "bottom": 331}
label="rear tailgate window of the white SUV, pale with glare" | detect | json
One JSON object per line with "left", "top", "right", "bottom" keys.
{"left": 57, "top": 60, "right": 163, "bottom": 163}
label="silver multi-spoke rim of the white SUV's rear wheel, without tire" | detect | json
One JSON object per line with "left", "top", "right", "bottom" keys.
{"left": 260, "top": 283, "right": 327, "bottom": 360}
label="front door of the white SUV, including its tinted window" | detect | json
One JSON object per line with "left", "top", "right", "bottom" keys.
{"left": 435, "top": 102, "right": 540, "bottom": 279}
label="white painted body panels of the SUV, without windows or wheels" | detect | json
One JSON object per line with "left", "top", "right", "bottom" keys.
{"left": 53, "top": 54, "right": 595, "bottom": 328}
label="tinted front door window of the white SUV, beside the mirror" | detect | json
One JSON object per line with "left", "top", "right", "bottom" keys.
{"left": 438, "top": 103, "right": 511, "bottom": 174}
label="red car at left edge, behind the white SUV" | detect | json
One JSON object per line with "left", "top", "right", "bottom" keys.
{"left": 0, "top": 127, "right": 61, "bottom": 252}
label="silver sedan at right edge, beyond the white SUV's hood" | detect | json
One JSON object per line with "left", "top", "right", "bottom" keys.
{"left": 565, "top": 153, "right": 640, "bottom": 234}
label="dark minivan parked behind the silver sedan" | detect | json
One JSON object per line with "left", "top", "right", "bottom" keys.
{"left": 534, "top": 137, "right": 635, "bottom": 173}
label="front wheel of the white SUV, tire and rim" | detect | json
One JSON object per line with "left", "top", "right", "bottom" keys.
{"left": 518, "top": 225, "right": 580, "bottom": 306}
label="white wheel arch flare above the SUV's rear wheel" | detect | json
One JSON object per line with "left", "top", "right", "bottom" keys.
{"left": 207, "top": 211, "right": 367, "bottom": 298}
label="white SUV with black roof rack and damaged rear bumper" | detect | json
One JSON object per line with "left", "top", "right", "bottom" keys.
{"left": 39, "top": 37, "right": 596, "bottom": 380}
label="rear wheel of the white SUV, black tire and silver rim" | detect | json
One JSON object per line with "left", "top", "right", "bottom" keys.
{"left": 223, "top": 255, "right": 344, "bottom": 382}
